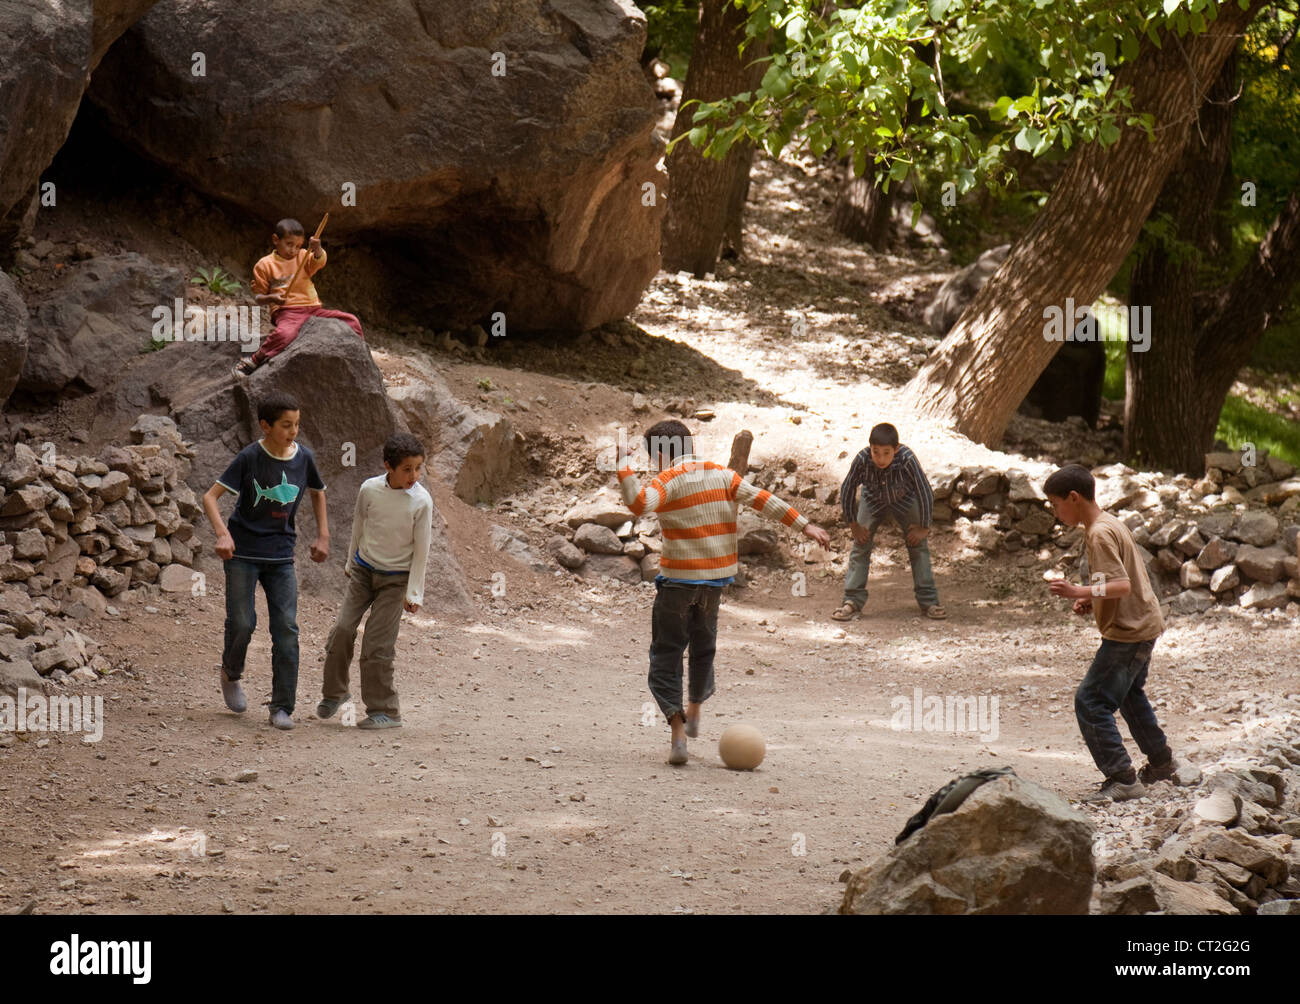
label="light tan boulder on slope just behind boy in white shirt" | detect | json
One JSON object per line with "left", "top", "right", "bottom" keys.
{"left": 389, "top": 360, "right": 515, "bottom": 505}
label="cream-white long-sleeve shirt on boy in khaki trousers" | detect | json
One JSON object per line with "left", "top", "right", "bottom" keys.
{"left": 347, "top": 475, "right": 433, "bottom": 603}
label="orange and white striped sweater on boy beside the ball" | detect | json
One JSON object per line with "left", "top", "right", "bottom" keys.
{"left": 619, "top": 455, "right": 809, "bottom": 581}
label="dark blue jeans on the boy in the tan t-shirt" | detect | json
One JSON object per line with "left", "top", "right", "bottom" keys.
{"left": 1074, "top": 639, "right": 1167, "bottom": 778}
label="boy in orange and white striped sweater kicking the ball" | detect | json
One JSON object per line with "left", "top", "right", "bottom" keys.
{"left": 619, "top": 421, "right": 831, "bottom": 765}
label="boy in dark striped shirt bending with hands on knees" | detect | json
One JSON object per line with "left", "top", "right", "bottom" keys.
{"left": 831, "top": 423, "right": 948, "bottom": 620}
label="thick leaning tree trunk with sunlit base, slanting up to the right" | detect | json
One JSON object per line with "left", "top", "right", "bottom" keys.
{"left": 907, "top": 0, "right": 1264, "bottom": 445}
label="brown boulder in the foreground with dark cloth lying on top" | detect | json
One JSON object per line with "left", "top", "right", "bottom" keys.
{"left": 840, "top": 775, "right": 1093, "bottom": 914}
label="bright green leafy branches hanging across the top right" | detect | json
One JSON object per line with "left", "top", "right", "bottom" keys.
{"left": 677, "top": 0, "right": 1248, "bottom": 218}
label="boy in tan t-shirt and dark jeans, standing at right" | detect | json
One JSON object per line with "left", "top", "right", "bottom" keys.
{"left": 1043, "top": 464, "right": 1178, "bottom": 802}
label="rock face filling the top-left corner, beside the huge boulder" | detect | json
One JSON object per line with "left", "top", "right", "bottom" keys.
{"left": 0, "top": 0, "right": 157, "bottom": 249}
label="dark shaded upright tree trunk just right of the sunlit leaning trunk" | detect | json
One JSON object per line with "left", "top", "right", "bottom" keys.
{"left": 1125, "top": 55, "right": 1236, "bottom": 475}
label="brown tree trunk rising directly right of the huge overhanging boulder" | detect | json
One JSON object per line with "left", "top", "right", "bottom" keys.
{"left": 663, "top": 0, "right": 766, "bottom": 277}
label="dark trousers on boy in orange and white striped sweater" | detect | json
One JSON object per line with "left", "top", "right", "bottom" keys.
{"left": 650, "top": 583, "right": 723, "bottom": 720}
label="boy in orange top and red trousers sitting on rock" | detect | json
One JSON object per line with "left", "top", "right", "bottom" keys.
{"left": 234, "top": 220, "right": 365, "bottom": 376}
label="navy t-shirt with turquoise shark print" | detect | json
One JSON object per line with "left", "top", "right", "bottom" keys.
{"left": 217, "top": 442, "right": 325, "bottom": 562}
